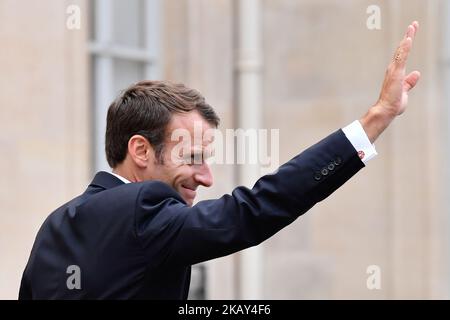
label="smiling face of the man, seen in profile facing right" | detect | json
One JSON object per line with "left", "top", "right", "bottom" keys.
{"left": 144, "top": 111, "right": 214, "bottom": 206}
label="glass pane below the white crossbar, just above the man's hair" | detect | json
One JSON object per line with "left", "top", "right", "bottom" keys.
{"left": 112, "top": 59, "right": 145, "bottom": 96}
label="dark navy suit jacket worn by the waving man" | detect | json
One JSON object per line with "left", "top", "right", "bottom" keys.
{"left": 19, "top": 130, "right": 364, "bottom": 299}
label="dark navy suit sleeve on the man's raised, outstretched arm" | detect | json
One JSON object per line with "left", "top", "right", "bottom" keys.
{"left": 135, "top": 130, "right": 364, "bottom": 265}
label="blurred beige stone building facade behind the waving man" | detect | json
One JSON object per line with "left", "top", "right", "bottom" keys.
{"left": 0, "top": 0, "right": 450, "bottom": 299}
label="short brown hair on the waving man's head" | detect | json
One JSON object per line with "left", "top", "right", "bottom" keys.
{"left": 105, "top": 80, "right": 220, "bottom": 168}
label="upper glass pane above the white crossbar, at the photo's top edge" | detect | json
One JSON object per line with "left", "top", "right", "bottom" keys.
{"left": 112, "top": 0, "right": 145, "bottom": 48}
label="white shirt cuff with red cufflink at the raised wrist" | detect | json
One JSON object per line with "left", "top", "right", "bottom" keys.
{"left": 342, "top": 120, "right": 378, "bottom": 164}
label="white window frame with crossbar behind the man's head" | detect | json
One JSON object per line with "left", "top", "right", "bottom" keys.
{"left": 88, "top": 0, "right": 162, "bottom": 171}
